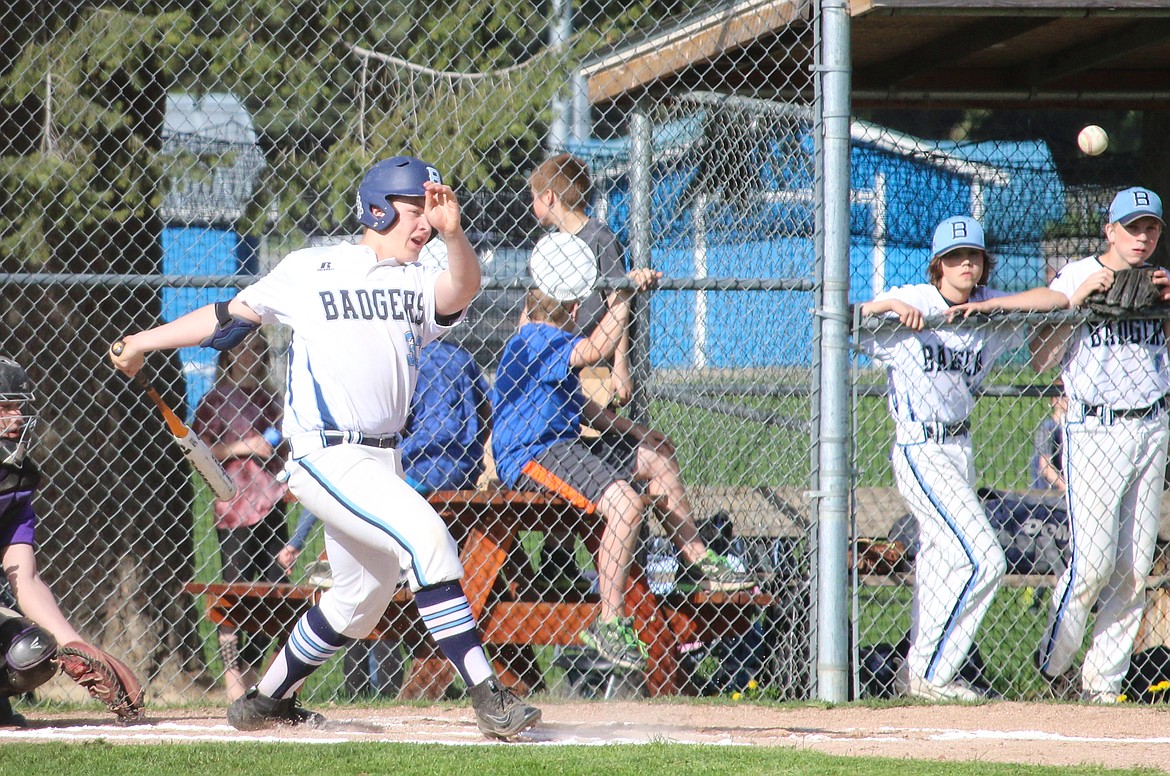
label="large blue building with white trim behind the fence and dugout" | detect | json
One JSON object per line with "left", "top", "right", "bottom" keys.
{"left": 567, "top": 100, "right": 1065, "bottom": 369}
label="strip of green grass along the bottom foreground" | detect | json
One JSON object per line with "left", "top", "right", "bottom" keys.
{"left": 0, "top": 742, "right": 1157, "bottom": 776}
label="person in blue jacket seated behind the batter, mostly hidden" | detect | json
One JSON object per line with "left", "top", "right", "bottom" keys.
{"left": 277, "top": 339, "right": 491, "bottom": 695}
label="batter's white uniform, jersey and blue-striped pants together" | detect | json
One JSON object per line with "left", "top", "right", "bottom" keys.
{"left": 238, "top": 243, "right": 463, "bottom": 638}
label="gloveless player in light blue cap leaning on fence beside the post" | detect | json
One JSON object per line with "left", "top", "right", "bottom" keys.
{"left": 860, "top": 215, "right": 1064, "bottom": 700}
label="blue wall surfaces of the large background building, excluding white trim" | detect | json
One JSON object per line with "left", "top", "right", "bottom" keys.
{"left": 571, "top": 114, "right": 1065, "bottom": 368}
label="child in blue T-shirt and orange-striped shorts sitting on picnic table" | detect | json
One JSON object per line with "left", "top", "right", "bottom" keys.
{"left": 491, "top": 244, "right": 752, "bottom": 669}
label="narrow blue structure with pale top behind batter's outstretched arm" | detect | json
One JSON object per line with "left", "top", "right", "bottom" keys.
{"left": 160, "top": 94, "right": 264, "bottom": 419}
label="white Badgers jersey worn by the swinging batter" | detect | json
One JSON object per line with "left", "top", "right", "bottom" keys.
{"left": 238, "top": 243, "right": 462, "bottom": 438}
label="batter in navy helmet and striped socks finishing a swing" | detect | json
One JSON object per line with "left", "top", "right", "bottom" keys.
{"left": 110, "top": 157, "right": 541, "bottom": 739}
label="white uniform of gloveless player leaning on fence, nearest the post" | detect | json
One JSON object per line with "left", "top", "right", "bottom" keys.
{"left": 860, "top": 283, "right": 1023, "bottom": 685}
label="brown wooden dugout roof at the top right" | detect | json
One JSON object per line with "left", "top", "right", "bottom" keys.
{"left": 581, "top": 0, "right": 1170, "bottom": 110}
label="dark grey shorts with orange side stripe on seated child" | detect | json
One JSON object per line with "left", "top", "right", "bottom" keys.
{"left": 522, "top": 434, "right": 638, "bottom": 514}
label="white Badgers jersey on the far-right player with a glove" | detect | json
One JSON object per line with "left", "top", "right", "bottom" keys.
{"left": 1049, "top": 256, "right": 1170, "bottom": 410}
